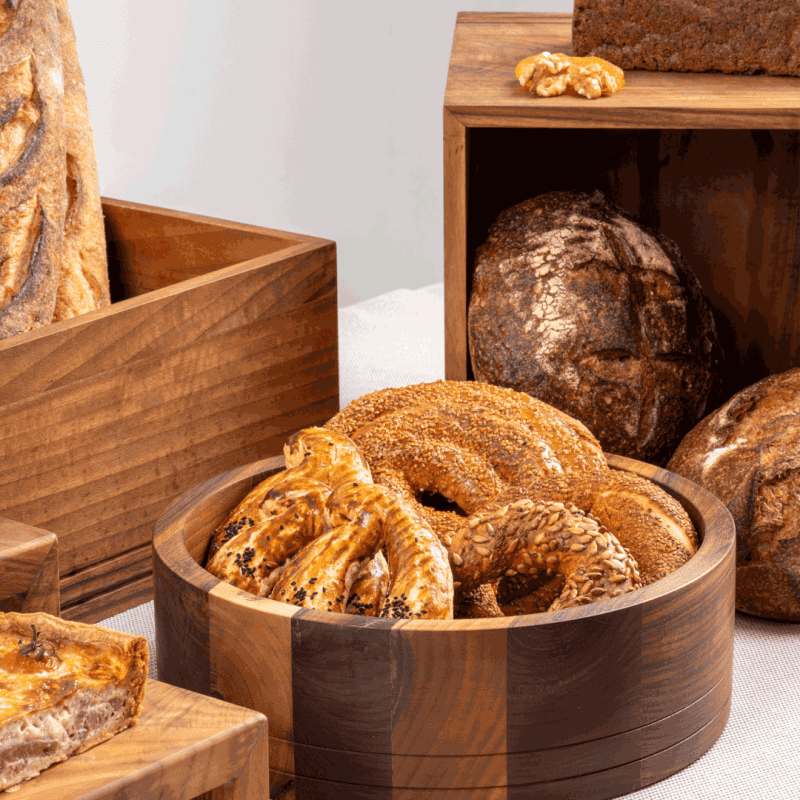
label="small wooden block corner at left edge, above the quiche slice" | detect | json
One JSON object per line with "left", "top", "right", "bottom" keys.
{"left": 0, "top": 517, "right": 61, "bottom": 617}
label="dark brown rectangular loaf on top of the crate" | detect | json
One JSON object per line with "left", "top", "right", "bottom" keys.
{"left": 572, "top": 0, "right": 800, "bottom": 75}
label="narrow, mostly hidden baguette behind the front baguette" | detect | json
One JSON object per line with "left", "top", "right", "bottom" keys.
{"left": 53, "top": 0, "right": 111, "bottom": 322}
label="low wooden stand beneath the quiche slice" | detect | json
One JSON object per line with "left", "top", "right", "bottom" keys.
{"left": 9, "top": 680, "right": 269, "bottom": 800}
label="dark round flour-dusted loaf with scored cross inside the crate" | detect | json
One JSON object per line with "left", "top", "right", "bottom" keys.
{"left": 468, "top": 191, "right": 722, "bottom": 464}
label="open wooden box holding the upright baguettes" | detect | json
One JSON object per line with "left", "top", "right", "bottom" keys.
{"left": 0, "top": 200, "right": 339, "bottom": 622}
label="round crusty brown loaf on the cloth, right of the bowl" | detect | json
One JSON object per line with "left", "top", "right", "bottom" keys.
{"left": 667, "top": 369, "right": 800, "bottom": 621}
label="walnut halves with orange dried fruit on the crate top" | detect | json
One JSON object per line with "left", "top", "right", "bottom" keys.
{"left": 515, "top": 51, "right": 625, "bottom": 99}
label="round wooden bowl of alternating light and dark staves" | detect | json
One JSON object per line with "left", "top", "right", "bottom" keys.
{"left": 154, "top": 456, "right": 735, "bottom": 800}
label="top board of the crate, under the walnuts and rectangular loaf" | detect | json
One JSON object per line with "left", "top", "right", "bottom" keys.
{"left": 444, "top": 12, "right": 800, "bottom": 130}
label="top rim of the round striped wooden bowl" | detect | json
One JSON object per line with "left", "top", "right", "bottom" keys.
{"left": 153, "top": 454, "right": 736, "bottom": 632}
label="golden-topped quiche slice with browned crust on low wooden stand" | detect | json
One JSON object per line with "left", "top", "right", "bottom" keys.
{"left": 0, "top": 613, "right": 149, "bottom": 790}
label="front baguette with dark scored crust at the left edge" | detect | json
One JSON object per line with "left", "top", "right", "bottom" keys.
{"left": 0, "top": 0, "right": 66, "bottom": 338}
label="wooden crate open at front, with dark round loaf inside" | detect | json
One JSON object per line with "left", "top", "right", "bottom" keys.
{"left": 444, "top": 13, "right": 800, "bottom": 406}
